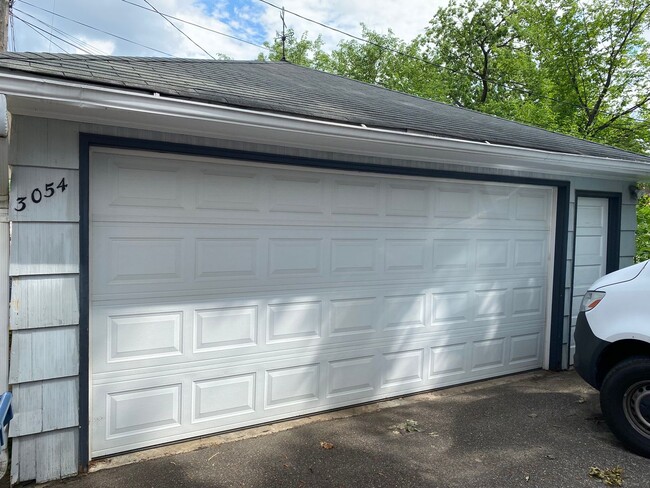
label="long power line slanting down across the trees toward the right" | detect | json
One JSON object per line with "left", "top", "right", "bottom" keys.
{"left": 258, "top": 0, "right": 648, "bottom": 125}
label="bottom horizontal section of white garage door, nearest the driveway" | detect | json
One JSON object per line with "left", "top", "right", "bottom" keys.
{"left": 93, "top": 320, "right": 541, "bottom": 455}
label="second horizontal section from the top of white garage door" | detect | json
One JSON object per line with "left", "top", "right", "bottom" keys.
{"left": 91, "top": 223, "right": 548, "bottom": 300}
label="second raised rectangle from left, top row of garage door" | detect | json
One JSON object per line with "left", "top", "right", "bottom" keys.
{"left": 196, "top": 169, "right": 260, "bottom": 211}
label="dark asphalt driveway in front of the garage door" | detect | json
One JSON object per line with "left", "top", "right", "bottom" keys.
{"left": 44, "top": 371, "right": 650, "bottom": 488}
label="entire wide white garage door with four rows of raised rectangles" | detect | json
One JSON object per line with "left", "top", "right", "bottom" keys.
{"left": 90, "top": 149, "right": 554, "bottom": 457}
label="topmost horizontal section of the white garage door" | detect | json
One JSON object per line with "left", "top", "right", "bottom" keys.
{"left": 91, "top": 151, "right": 550, "bottom": 230}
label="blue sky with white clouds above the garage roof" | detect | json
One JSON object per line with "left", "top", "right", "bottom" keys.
{"left": 9, "top": 0, "right": 447, "bottom": 59}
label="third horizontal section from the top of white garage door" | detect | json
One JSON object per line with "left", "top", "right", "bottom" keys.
{"left": 92, "top": 278, "right": 546, "bottom": 374}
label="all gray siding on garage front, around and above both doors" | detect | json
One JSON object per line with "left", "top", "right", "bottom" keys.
{"left": 9, "top": 116, "right": 636, "bottom": 482}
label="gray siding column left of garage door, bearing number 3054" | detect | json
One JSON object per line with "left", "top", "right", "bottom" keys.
{"left": 9, "top": 117, "right": 79, "bottom": 483}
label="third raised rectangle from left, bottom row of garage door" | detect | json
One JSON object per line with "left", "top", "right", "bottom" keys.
{"left": 266, "top": 364, "right": 320, "bottom": 408}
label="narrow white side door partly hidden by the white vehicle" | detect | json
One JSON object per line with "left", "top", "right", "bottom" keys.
{"left": 569, "top": 197, "right": 609, "bottom": 364}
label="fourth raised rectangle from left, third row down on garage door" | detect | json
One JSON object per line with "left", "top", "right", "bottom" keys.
{"left": 330, "top": 297, "right": 378, "bottom": 336}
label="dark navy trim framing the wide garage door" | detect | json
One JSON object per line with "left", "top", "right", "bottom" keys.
{"left": 79, "top": 133, "right": 570, "bottom": 471}
